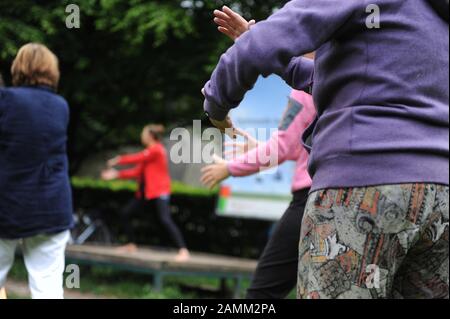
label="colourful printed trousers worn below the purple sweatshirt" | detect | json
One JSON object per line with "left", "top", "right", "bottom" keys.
{"left": 298, "top": 184, "right": 449, "bottom": 299}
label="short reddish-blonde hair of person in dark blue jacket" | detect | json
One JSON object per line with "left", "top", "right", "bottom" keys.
{"left": 11, "top": 43, "right": 60, "bottom": 89}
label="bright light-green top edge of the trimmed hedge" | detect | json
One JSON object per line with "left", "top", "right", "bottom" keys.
{"left": 72, "top": 177, "right": 218, "bottom": 197}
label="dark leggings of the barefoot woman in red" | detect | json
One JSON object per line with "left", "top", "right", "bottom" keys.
{"left": 120, "top": 197, "right": 187, "bottom": 249}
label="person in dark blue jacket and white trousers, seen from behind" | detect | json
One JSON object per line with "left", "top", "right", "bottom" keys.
{"left": 0, "top": 43, "right": 73, "bottom": 299}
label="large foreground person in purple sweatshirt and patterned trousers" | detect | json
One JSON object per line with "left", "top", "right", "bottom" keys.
{"left": 203, "top": 0, "right": 449, "bottom": 299}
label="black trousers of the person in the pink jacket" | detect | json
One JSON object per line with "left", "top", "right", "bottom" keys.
{"left": 247, "top": 189, "right": 309, "bottom": 299}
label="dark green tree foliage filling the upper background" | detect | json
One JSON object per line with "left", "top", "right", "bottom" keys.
{"left": 0, "top": 0, "right": 283, "bottom": 172}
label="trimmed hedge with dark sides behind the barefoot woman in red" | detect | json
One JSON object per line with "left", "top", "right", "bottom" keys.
{"left": 72, "top": 177, "right": 271, "bottom": 258}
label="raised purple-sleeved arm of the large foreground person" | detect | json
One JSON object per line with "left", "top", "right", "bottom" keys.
{"left": 204, "top": 0, "right": 365, "bottom": 121}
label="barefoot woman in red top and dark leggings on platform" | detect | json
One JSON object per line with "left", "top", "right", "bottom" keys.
{"left": 102, "top": 125, "right": 189, "bottom": 261}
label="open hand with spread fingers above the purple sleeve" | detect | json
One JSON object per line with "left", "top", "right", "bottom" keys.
{"left": 214, "top": 6, "right": 256, "bottom": 41}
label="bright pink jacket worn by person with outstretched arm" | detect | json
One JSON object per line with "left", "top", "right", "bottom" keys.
{"left": 228, "top": 90, "right": 316, "bottom": 192}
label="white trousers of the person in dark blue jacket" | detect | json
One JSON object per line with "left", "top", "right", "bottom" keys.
{"left": 0, "top": 231, "right": 70, "bottom": 299}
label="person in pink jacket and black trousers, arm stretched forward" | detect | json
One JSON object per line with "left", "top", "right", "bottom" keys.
{"left": 202, "top": 90, "right": 316, "bottom": 299}
